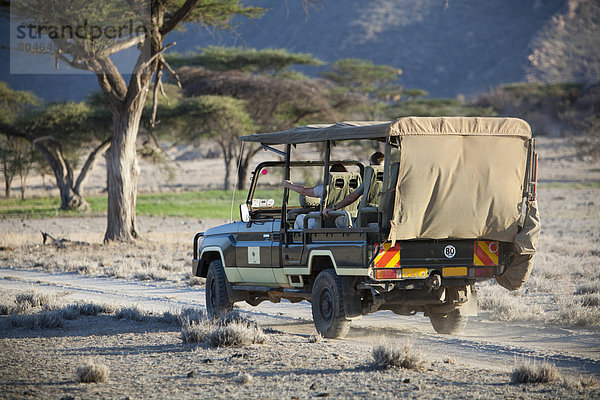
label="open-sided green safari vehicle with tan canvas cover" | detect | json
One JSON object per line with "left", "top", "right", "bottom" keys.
{"left": 193, "top": 117, "right": 539, "bottom": 338}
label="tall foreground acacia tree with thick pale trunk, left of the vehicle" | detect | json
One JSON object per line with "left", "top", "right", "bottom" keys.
{"left": 11, "top": 0, "right": 261, "bottom": 242}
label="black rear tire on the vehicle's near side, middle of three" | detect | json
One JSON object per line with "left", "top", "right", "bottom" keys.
{"left": 311, "top": 269, "right": 351, "bottom": 339}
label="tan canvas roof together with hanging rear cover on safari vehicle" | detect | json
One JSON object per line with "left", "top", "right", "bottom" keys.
{"left": 241, "top": 117, "right": 531, "bottom": 242}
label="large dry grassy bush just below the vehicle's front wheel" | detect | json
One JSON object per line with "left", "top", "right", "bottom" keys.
{"left": 181, "top": 313, "right": 267, "bottom": 347}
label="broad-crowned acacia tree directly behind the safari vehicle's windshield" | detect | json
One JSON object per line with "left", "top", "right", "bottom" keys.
{"left": 165, "top": 46, "right": 349, "bottom": 189}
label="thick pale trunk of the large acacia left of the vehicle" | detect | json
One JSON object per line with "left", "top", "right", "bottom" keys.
{"left": 104, "top": 101, "right": 146, "bottom": 242}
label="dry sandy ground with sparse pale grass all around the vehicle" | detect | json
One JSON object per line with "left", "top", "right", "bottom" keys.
{"left": 0, "top": 138, "right": 600, "bottom": 399}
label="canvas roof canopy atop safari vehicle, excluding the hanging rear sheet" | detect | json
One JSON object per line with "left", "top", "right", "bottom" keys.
{"left": 240, "top": 117, "right": 531, "bottom": 145}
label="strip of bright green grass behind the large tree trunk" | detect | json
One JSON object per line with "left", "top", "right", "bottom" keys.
{"left": 0, "top": 190, "right": 281, "bottom": 219}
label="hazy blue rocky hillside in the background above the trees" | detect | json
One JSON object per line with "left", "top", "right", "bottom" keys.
{"left": 5, "top": 0, "right": 600, "bottom": 99}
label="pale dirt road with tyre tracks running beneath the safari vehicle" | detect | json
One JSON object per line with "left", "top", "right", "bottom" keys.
{"left": 0, "top": 268, "right": 600, "bottom": 384}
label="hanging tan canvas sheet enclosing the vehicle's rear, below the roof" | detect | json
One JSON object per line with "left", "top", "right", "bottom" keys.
{"left": 389, "top": 134, "right": 527, "bottom": 242}
